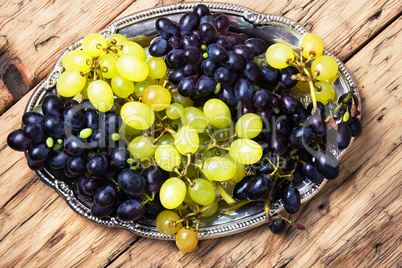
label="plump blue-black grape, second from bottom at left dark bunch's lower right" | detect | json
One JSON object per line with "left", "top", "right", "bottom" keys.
{"left": 117, "top": 169, "right": 146, "bottom": 195}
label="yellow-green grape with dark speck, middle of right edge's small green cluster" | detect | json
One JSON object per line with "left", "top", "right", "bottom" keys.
{"left": 311, "top": 55, "right": 338, "bottom": 81}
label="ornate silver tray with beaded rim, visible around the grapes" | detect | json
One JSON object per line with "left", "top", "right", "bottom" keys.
{"left": 26, "top": 3, "right": 360, "bottom": 240}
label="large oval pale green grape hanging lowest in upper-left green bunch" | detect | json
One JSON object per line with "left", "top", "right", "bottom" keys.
{"left": 87, "top": 80, "right": 114, "bottom": 112}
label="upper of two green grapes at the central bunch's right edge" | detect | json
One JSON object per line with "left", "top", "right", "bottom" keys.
{"left": 235, "top": 113, "right": 262, "bottom": 139}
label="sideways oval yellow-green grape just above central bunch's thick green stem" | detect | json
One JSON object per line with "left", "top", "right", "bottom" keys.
{"left": 202, "top": 156, "right": 236, "bottom": 181}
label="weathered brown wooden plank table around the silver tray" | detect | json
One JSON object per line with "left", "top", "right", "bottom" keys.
{"left": 0, "top": 0, "right": 402, "bottom": 267}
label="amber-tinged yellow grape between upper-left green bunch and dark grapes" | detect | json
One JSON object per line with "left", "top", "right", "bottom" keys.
{"left": 142, "top": 85, "right": 172, "bottom": 112}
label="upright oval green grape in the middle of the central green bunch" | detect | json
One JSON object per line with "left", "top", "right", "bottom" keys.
{"left": 174, "top": 126, "right": 200, "bottom": 155}
